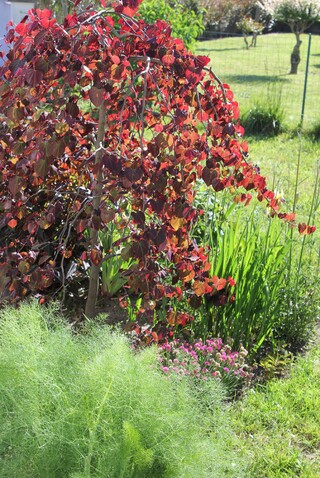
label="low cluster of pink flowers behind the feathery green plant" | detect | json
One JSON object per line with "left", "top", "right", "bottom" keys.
{"left": 160, "top": 339, "right": 253, "bottom": 390}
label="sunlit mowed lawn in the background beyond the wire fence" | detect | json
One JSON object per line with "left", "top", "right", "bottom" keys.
{"left": 197, "top": 32, "right": 320, "bottom": 127}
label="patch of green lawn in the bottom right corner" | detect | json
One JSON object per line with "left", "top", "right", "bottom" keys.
{"left": 232, "top": 347, "right": 320, "bottom": 478}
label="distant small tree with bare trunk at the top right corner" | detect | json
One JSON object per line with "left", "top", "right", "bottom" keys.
{"left": 258, "top": 0, "right": 320, "bottom": 75}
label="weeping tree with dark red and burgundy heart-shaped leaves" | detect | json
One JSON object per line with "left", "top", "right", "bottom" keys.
{"left": 0, "top": 0, "right": 312, "bottom": 317}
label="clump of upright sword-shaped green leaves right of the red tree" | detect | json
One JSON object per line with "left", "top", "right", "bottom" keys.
{"left": 193, "top": 191, "right": 290, "bottom": 355}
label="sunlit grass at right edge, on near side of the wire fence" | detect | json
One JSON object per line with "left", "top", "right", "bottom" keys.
{"left": 247, "top": 133, "right": 320, "bottom": 274}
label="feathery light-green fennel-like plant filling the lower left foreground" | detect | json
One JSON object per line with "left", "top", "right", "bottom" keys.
{"left": 0, "top": 302, "right": 246, "bottom": 478}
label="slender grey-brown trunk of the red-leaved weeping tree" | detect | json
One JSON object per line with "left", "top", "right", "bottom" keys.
{"left": 85, "top": 101, "right": 106, "bottom": 318}
